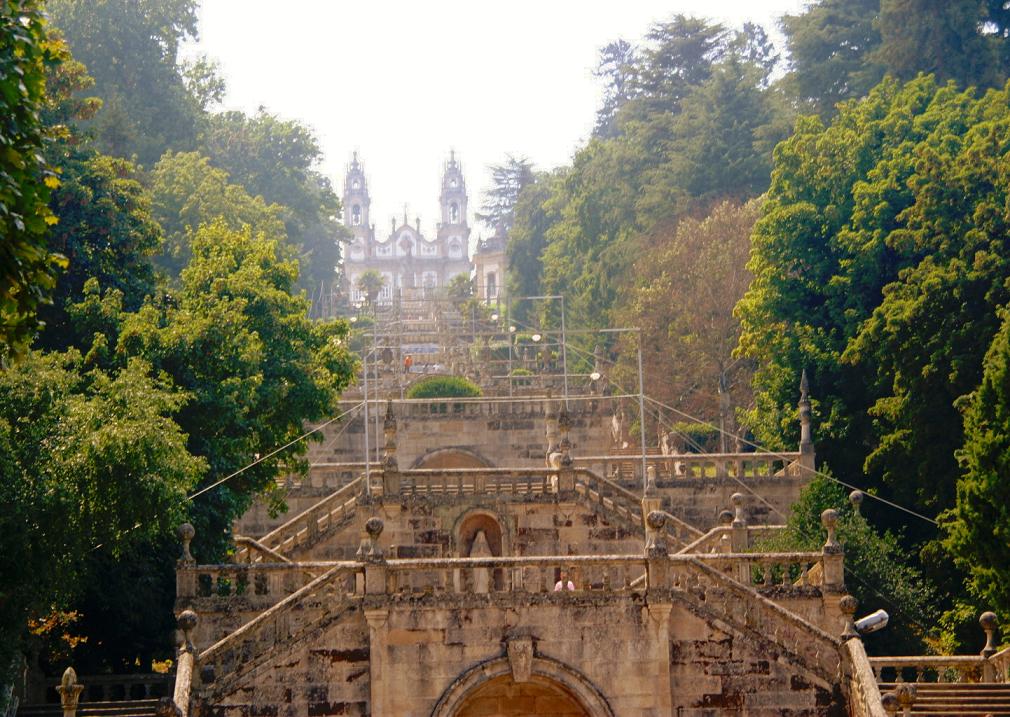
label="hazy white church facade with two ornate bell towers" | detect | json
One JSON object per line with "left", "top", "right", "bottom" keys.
{"left": 343, "top": 152, "right": 472, "bottom": 304}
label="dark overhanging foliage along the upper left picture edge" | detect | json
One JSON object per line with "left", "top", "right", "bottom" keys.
{"left": 0, "top": 0, "right": 66, "bottom": 365}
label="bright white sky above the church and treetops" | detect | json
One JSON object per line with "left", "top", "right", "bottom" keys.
{"left": 185, "top": 0, "right": 805, "bottom": 236}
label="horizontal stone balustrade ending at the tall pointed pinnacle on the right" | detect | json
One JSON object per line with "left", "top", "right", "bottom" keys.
{"left": 574, "top": 451, "right": 802, "bottom": 483}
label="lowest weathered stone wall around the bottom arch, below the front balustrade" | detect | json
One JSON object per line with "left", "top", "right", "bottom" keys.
{"left": 203, "top": 593, "right": 844, "bottom": 717}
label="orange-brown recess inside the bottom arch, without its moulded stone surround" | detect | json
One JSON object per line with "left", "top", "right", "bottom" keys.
{"left": 453, "top": 675, "right": 590, "bottom": 717}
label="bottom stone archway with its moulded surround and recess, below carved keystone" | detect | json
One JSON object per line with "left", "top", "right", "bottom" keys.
{"left": 431, "top": 656, "right": 614, "bottom": 717}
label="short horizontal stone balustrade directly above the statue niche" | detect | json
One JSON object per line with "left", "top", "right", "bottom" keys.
{"left": 400, "top": 468, "right": 557, "bottom": 496}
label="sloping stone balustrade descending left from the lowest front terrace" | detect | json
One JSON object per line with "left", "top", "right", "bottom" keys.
{"left": 199, "top": 561, "right": 361, "bottom": 688}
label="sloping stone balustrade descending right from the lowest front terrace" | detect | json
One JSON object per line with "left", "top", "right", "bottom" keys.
{"left": 670, "top": 555, "right": 841, "bottom": 683}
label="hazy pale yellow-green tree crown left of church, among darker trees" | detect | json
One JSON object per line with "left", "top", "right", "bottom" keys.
{"left": 150, "top": 151, "right": 286, "bottom": 280}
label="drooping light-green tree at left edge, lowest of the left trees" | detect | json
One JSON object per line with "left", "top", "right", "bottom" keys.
{"left": 0, "top": 350, "right": 206, "bottom": 694}
